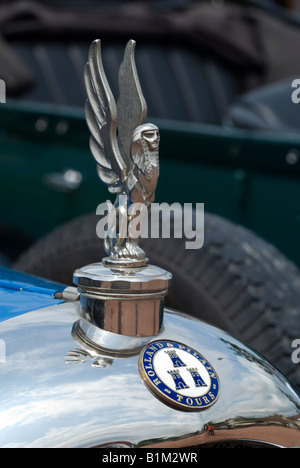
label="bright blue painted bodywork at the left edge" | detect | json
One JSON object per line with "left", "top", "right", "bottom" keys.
{"left": 0, "top": 267, "right": 65, "bottom": 322}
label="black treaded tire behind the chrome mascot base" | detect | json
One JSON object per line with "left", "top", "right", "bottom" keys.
{"left": 14, "top": 214, "right": 300, "bottom": 386}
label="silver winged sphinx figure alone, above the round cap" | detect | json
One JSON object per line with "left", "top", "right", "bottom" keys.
{"left": 84, "top": 40, "right": 160, "bottom": 265}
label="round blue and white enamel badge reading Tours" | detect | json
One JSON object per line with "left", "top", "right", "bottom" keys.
{"left": 139, "top": 341, "right": 220, "bottom": 411}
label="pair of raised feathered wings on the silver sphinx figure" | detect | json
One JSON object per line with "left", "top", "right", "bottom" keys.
{"left": 84, "top": 39, "right": 147, "bottom": 192}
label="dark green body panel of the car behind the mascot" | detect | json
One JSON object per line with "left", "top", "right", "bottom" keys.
{"left": 0, "top": 102, "right": 300, "bottom": 265}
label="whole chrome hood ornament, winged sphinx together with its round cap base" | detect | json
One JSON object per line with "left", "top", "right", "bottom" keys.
{"left": 73, "top": 40, "right": 172, "bottom": 355}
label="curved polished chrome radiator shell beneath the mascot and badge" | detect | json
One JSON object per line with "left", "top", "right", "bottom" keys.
{"left": 0, "top": 301, "right": 300, "bottom": 448}
